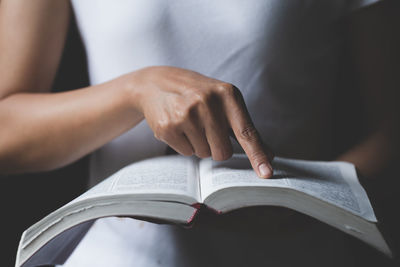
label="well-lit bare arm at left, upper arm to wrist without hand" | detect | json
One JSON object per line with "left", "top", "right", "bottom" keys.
{"left": 0, "top": 0, "right": 142, "bottom": 173}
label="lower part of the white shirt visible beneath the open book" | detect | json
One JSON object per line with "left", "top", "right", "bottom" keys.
{"left": 63, "top": 218, "right": 351, "bottom": 267}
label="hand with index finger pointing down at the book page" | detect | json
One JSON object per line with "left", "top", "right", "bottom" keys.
{"left": 126, "top": 67, "right": 272, "bottom": 178}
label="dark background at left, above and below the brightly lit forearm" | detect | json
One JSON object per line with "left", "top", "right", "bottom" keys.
{"left": 0, "top": 14, "right": 88, "bottom": 267}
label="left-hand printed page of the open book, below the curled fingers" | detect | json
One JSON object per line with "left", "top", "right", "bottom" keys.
{"left": 74, "top": 155, "right": 200, "bottom": 203}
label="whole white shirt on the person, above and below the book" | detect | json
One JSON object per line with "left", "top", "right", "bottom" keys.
{"left": 65, "top": 0, "right": 382, "bottom": 267}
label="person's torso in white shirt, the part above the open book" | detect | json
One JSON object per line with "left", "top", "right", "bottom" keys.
{"left": 72, "top": 0, "right": 360, "bottom": 184}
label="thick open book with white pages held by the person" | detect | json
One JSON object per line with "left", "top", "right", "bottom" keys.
{"left": 16, "top": 154, "right": 391, "bottom": 267}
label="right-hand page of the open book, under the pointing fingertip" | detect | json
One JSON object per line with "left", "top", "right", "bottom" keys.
{"left": 200, "top": 154, "right": 376, "bottom": 221}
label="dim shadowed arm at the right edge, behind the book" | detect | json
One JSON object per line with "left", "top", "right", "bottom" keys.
{"left": 339, "top": 1, "right": 400, "bottom": 177}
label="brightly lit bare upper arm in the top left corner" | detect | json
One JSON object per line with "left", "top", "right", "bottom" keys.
{"left": 0, "top": 0, "right": 70, "bottom": 99}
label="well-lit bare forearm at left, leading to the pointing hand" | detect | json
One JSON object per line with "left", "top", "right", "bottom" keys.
{"left": 0, "top": 77, "right": 142, "bottom": 173}
